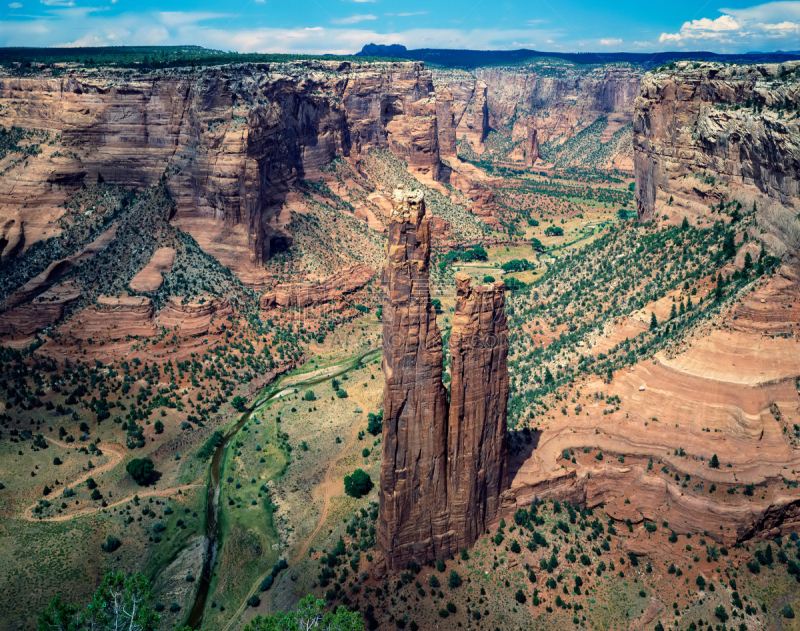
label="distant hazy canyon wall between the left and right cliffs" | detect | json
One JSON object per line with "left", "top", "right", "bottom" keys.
{"left": 433, "top": 62, "right": 642, "bottom": 171}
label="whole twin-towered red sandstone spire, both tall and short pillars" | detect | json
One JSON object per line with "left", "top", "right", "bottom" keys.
{"left": 376, "top": 190, "right": 508, "bottom": 573}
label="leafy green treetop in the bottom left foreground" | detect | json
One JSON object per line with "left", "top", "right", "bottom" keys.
{"left": 38, "top": 572, "right": 165, "bottom": 631}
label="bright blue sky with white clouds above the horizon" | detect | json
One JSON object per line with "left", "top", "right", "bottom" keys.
{"left": 0, "top": 0, "right": 800, "bottom": 53}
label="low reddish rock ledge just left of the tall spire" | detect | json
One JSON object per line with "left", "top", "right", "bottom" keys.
{"left": 260, "top": 263, "right": 375, "bottom": 311}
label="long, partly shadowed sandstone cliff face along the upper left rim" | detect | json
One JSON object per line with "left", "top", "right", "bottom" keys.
{"left": 0, "top": 62, "right": 440, "bottom": 265}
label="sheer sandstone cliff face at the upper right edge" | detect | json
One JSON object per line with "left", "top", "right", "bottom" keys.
{"left": 634, "top": 62, "right": 800, "bottom": 221}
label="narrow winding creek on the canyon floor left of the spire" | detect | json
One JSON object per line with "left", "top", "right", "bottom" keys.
{"left": 187, "top": 348, "right": 381, "bottom": 629}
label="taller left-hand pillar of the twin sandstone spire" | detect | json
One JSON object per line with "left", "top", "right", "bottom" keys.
{"left": 377, "top": 189, "right": 451, "bottom": 571}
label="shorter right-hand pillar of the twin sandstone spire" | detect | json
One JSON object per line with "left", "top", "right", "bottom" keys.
{"left": 447, "top": 272, "right": 508, "bottom": 549}
